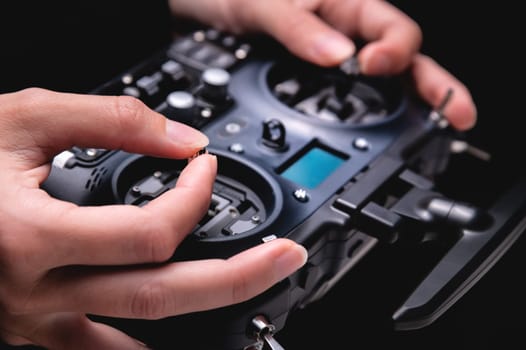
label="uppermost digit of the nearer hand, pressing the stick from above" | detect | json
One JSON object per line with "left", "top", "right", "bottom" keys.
{"left": 0, "top": 88, "right": 208, "bottom": 162}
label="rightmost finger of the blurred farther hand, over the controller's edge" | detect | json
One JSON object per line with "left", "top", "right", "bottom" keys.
{"left": 411, "top": 54, "right": 477, "bottom": 130}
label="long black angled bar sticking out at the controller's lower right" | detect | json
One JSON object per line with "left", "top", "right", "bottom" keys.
{"left": 393, "top": 181, "right": 526, "bottom": 330}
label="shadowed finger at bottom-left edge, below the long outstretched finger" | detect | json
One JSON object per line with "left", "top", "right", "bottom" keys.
{"left": 6, "top": 312, "right": 151, "bottom": 350}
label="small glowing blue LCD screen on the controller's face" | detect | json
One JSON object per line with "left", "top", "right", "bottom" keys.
{"left": 281, "top": 147, "right": 345, "bottom": 188}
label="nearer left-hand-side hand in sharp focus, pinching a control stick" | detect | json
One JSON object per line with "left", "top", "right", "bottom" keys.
{"left": 0, "top": 88, "right": 306, "bottom": 350}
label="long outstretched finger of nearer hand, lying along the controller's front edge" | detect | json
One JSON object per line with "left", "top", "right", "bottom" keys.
{"left": 27, "top": 239, "right": 307, "bottom": 319}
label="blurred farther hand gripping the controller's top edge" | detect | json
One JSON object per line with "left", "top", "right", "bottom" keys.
{"left": 170, "top": 0, "right": 477, "bottom": 130}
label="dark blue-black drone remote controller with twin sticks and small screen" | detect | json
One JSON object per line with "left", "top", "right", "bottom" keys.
{"left": 42, "top": 29, "right": 526, "bottom": 350}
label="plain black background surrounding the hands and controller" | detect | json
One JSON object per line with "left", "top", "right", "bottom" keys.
{"left": 0, "top": 0, "right": 526, "bottom": 350}
